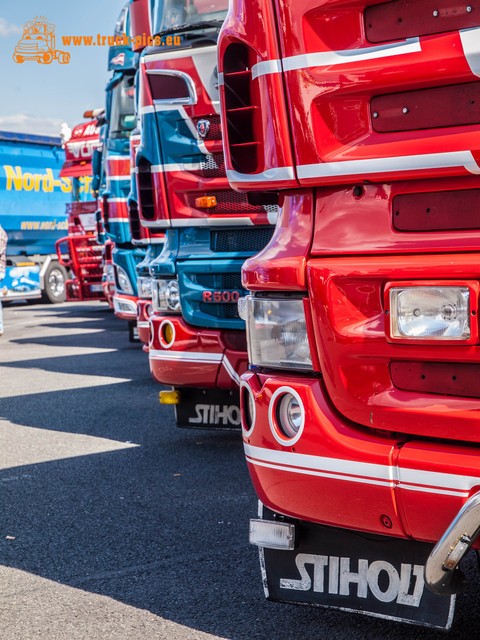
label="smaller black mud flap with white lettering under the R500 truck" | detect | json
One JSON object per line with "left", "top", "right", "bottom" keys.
{"left": 175, "top": 389, "right": 241, "bottom": 431}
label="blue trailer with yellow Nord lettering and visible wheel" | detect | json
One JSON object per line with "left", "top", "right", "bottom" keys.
{"left": 0, "top": 132, "right": 72, "bottom": 302}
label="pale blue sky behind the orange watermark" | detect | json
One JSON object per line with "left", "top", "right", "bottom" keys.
{"left": 0, "top": 0, "right": 125, "bottom": 135}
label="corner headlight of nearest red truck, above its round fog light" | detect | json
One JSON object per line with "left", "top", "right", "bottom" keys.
{"left": 239, "top": 296, "right": 313, "bottom": 370}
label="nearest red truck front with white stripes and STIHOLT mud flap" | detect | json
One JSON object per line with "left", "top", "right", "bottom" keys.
{"left": 219, "top": 0, "right": 480, "bottom": 628}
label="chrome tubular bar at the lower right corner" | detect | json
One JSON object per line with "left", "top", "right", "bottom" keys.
{"left": 425, "top": 491, "right": 480, "bottom": 595}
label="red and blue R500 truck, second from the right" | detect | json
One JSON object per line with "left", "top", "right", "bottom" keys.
{"left": 135, "top": 0, "right": 278, "bottom": 428}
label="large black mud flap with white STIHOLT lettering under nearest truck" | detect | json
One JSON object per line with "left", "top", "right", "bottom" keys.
{"left": 260, "top": 508, "right": 455, "bottom": 630}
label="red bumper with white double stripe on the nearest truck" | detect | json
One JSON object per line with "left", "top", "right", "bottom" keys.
{"left": 241, "top": 372, "right": 480, "bottom": 542}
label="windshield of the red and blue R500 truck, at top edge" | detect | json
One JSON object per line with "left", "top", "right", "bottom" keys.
{"left": 154, "top": 0, "right": 228, "bottom": 34}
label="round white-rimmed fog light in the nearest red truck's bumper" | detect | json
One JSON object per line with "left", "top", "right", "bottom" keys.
{"left": 269, "top": 387, "right": 305, "bottom": 445}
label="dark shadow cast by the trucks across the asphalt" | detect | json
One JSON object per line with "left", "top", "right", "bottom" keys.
{"left": 0, "top": 314, "right": 480, "bottom": 640}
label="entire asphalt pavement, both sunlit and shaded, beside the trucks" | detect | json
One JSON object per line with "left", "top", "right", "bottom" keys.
{"left": 0, "top": 303, "right": 480, "bottom": 640}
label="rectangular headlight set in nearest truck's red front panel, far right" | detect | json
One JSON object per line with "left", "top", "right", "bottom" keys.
{"left": 387, "top": 283, "right": 475, "bottom": 341}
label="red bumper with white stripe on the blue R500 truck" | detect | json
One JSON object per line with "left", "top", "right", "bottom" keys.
{"left": 149, "top": 315, "right": 248, "bottom": 389}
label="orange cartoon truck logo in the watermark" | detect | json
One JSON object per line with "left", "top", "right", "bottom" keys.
{"left": 13, "top": 16, "right": 70, "bottom": 64}
